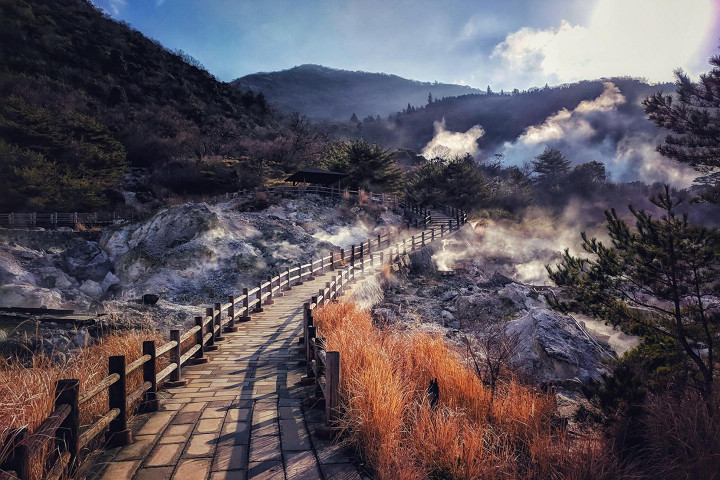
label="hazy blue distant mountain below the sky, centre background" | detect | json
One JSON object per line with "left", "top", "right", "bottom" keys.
{"left": 230, "top": 65, "right": 481, "bottom": 121}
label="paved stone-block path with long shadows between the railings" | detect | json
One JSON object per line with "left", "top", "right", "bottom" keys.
{"left": 86, "top": 274, "right": 361, "bottom": 480}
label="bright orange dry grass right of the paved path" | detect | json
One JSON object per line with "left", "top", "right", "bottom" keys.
{"left": 314, "top": 303, "right": 594, "bottom": 480}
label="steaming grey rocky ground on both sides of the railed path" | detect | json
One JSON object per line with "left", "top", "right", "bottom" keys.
{"left": 0, "top": 197, "right": 637, "bottom": 420}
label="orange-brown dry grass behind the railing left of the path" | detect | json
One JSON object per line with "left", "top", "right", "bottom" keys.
{"left": 0, "top": 332, "right": 163, "bottom": 463}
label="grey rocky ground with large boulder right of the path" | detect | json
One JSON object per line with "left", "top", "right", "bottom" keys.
{"left": 368, "top": 225, "right": 639, "bottom": 417}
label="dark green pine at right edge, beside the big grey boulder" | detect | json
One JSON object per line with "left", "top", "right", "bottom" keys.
{"left": 548, "top": 186, "right": 720, "bottom": 405}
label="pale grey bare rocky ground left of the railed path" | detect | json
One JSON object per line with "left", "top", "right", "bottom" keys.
{"left": 0, "top": 195, "right": 401, "bottom": 351}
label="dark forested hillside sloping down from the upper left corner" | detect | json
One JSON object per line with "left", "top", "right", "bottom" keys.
{"left": 0, "top": 0, "right": 276, "bottom": 210}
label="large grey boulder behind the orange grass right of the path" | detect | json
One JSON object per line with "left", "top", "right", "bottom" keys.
{"left": 506, "top": 308, "right": 614, "bottom": 388}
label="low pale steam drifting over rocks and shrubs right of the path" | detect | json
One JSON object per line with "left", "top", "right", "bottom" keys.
{"left": 433, "top": 200, "right": 603, "bottom": 285}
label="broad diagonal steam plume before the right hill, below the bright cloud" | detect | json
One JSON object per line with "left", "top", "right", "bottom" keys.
{"left": 502, "top": 82, "right": 697, "bottom": 188}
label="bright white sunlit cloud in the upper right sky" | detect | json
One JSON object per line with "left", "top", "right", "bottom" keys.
{"left": 491, "top": 0, "right": 715, "bottom": 83}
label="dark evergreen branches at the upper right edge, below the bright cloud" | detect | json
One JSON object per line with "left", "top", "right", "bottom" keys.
{"left": 643, "top": 52, "right": 720, "bottom": 202}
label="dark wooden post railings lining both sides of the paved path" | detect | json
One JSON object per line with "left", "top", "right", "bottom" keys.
{"left": 0, "top": 189, "right": 466, "bottom": 480}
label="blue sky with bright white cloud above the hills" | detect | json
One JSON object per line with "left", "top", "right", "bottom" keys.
{"left": 93, "top": 0, "right": 720, "bottom": 90}
